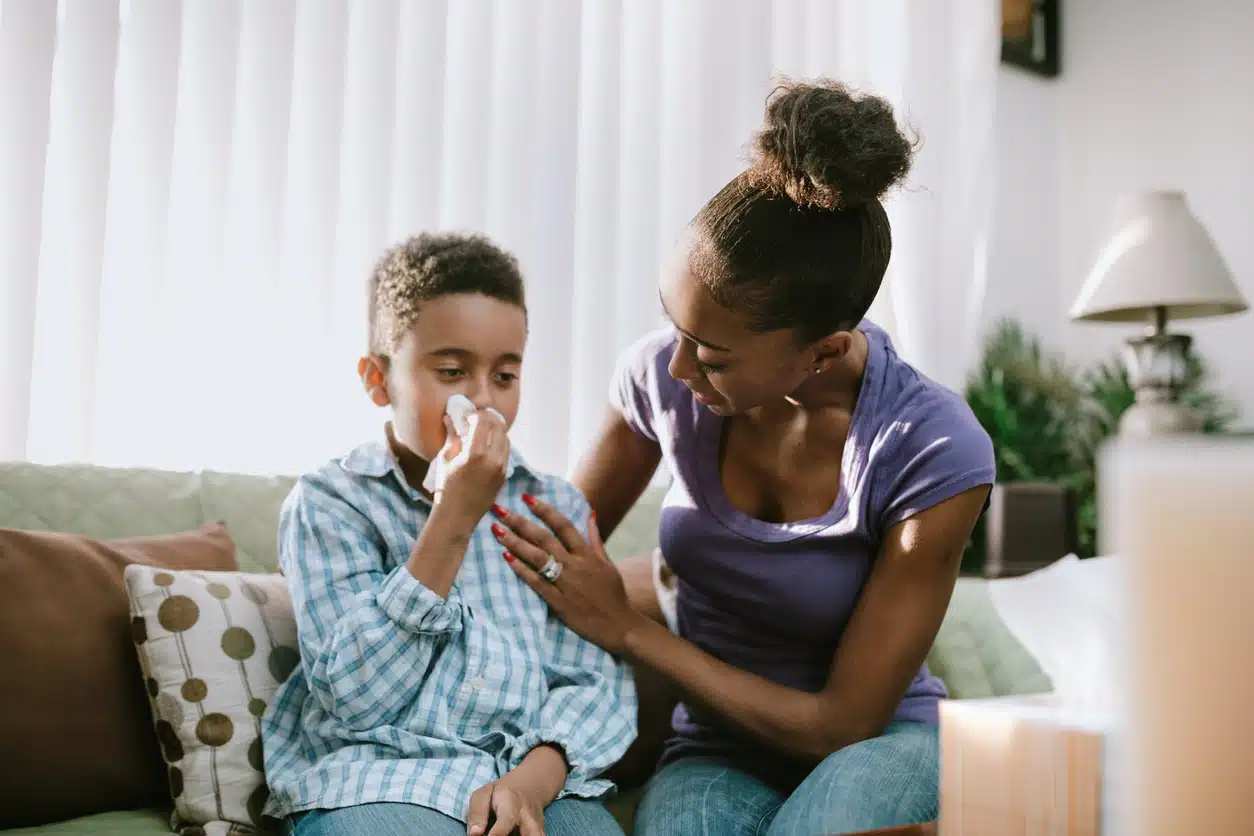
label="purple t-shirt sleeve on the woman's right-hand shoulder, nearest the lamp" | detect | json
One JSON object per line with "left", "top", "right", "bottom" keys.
{"left": 879, "top": 397, "right": 997, "bottom": 531}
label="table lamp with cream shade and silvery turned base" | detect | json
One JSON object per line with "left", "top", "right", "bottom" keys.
{"left": 1071, "top": 192, "right": 1249, "bottom": 437}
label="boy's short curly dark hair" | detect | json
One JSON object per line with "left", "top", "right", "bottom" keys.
{"left": 367, "top": 232, "right": 527, "bottom": 357}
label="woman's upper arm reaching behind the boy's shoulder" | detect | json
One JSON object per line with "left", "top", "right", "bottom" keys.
{"left": 572, "top": 406, "right": 662, "bottom": 538}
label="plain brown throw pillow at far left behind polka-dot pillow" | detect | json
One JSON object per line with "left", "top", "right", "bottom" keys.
{"left": 0, "top": 523, "right": 238, "bottom": 830}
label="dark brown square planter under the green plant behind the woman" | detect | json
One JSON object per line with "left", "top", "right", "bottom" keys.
{"left": 984, "top": 481, "right": 1076, "bottom": 578}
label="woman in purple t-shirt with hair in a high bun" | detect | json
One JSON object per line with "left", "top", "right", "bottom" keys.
{"left": 489, "top": 83, "right": 993, "bottom": 836}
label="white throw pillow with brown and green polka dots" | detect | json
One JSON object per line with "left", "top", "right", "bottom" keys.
{"left": 125, "top": 565, "right": 300, "bottom": 836}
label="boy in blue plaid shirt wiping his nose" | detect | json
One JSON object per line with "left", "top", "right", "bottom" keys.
{"left": 262, "top": 234, "right": 636, "bottom": 836}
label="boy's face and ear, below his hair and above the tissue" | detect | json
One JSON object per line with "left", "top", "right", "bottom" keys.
{"left": 357, "top": 293, "right": 527, "bottom": 461}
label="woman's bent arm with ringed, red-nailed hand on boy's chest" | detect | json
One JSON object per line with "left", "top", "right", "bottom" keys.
{"left": 504, "top": 485, "right": 988, "bottom": 762}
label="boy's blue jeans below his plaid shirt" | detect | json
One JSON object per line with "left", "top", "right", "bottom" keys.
{"left": 285, "top": 798, "right": 623, "bottom": 836}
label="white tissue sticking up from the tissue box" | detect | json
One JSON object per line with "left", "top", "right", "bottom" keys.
{"left": 988, "top": 555, "right": 1125, "bottom": 716}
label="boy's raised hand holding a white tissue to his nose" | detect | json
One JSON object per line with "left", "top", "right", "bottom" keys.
{"left": 423, "top": 395, "right": 509, "bottom": 528}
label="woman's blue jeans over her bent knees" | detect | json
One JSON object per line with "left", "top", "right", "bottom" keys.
{"left": 633, "top": 723, "right": 941, "bottom": 836}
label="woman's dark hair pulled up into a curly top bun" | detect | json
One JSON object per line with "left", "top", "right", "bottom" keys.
{"left": 691, "top": 79, "right": 914, "bottom": 341}
